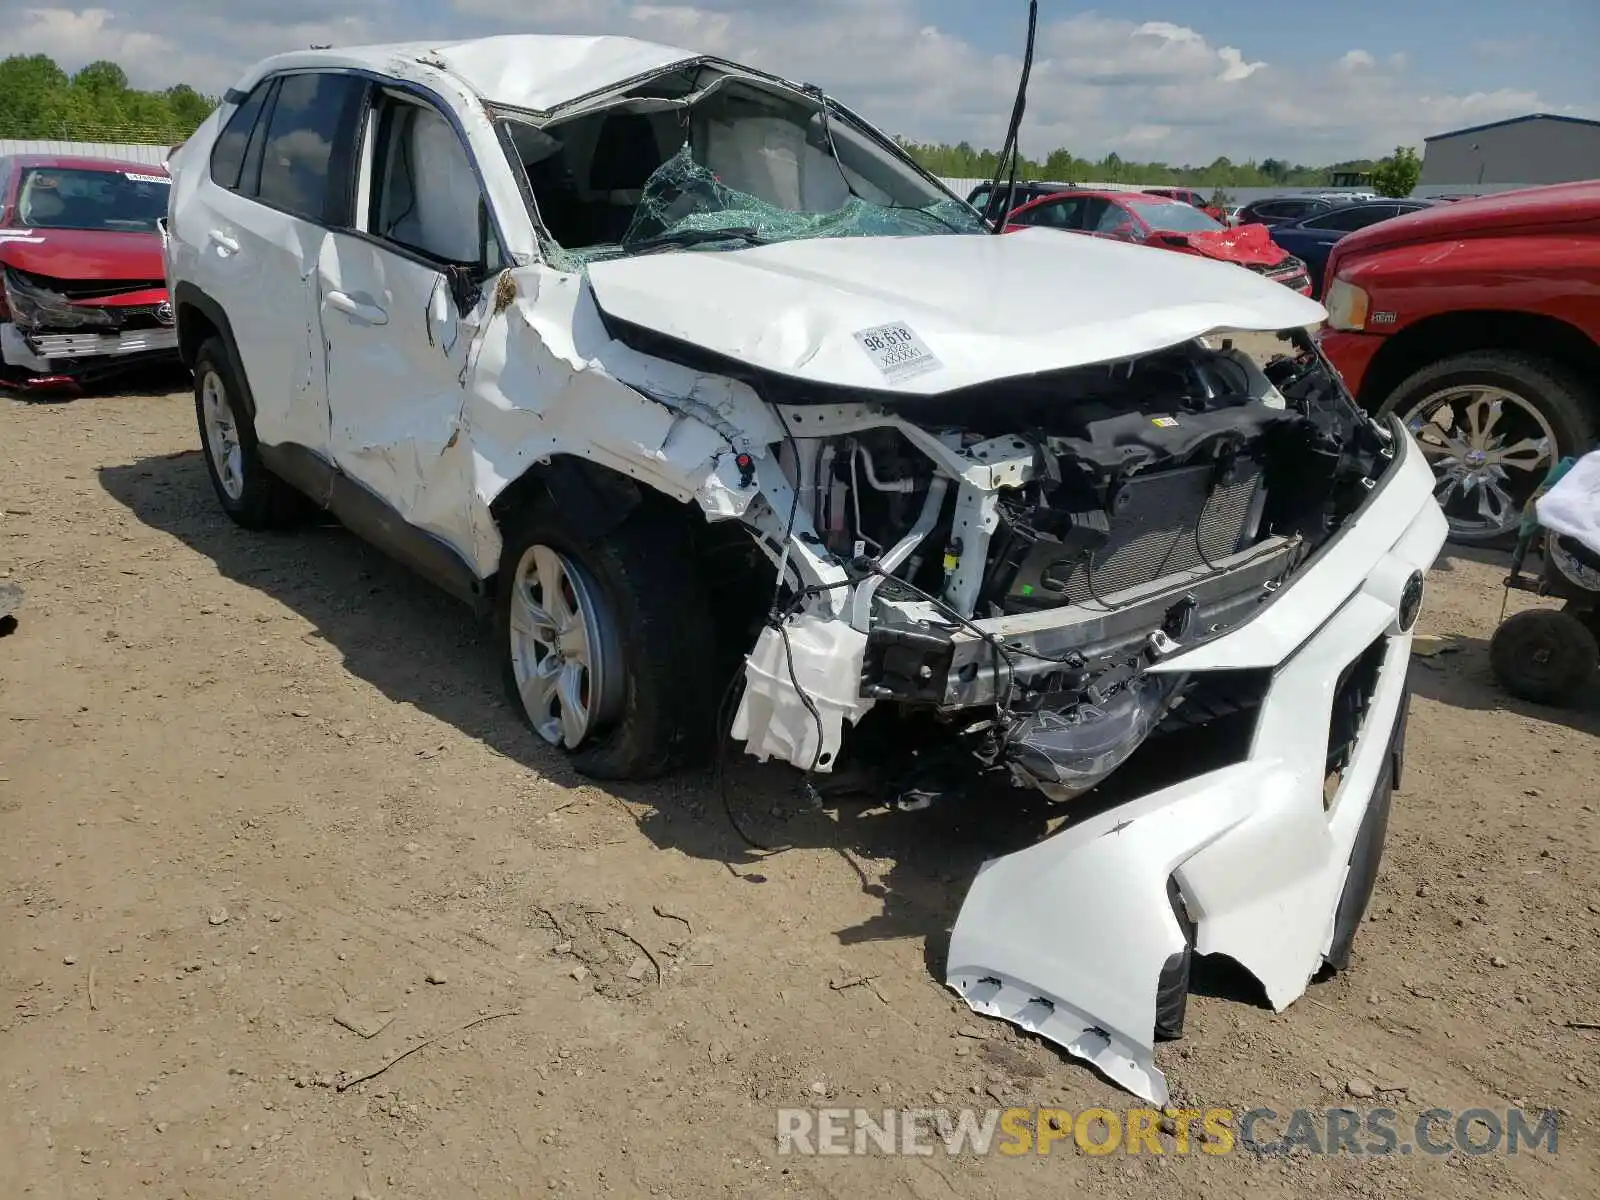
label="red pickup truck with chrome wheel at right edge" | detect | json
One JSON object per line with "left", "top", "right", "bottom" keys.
{"left": 1320, "top": 181, "right": 1600, "bottom": 544}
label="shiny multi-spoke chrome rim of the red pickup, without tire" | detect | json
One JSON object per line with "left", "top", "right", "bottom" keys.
{"left": 1405, "top": 386, "right": 1555, "bottom": 541}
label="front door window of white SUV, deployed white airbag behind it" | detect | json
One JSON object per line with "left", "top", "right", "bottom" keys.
{"left": 368, "top": 99, "right": 501, "bottom": 267}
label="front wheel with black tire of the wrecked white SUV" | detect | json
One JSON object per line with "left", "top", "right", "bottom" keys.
{"left": 496, "top": 498, "right": 718, "bottom": 779}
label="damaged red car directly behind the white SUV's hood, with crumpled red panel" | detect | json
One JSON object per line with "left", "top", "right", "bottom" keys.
{"left": 1006, "top": 192, "right": 1310, "bottom": 296}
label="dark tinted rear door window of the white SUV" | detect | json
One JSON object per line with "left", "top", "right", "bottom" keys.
{"left": 256, "top": 74, "right": 366, "bottom": 224}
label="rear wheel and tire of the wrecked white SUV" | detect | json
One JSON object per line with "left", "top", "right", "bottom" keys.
{"left": 194, "top": 338, "right": 315, "bottom": 530}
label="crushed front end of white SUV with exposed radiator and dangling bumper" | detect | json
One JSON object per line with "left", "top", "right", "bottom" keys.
{"left": 720, "top": 331, "right": 1445, "bottom": 1101}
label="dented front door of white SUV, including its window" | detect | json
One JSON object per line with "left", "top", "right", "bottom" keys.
{"left": 318, "top": 91, "right": 501, "bottom": 555}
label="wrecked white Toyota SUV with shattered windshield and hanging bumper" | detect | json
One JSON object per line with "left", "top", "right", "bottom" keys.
{"left": 166, "top": 37, "right": 1445, "bottom": 1099}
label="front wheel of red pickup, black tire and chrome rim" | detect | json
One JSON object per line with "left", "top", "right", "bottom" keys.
{"left": 1379, "top": 350, "right": 1595, "bottom": 546}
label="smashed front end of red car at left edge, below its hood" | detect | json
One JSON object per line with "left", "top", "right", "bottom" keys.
{"left": 0, "top": 266, "right": 178, "bottom": 387}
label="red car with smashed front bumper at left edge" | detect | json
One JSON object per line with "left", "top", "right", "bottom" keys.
{"left": 0, "top": 155, "right": 178, "bottom": 389}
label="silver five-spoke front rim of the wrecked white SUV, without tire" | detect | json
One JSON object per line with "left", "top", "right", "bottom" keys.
{"left": 510, "top": 544, "right": 622, "bottom": 750}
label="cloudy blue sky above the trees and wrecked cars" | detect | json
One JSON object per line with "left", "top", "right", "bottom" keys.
{"left": 0, "top": 0, "right": 1600, "bottom": 163}
